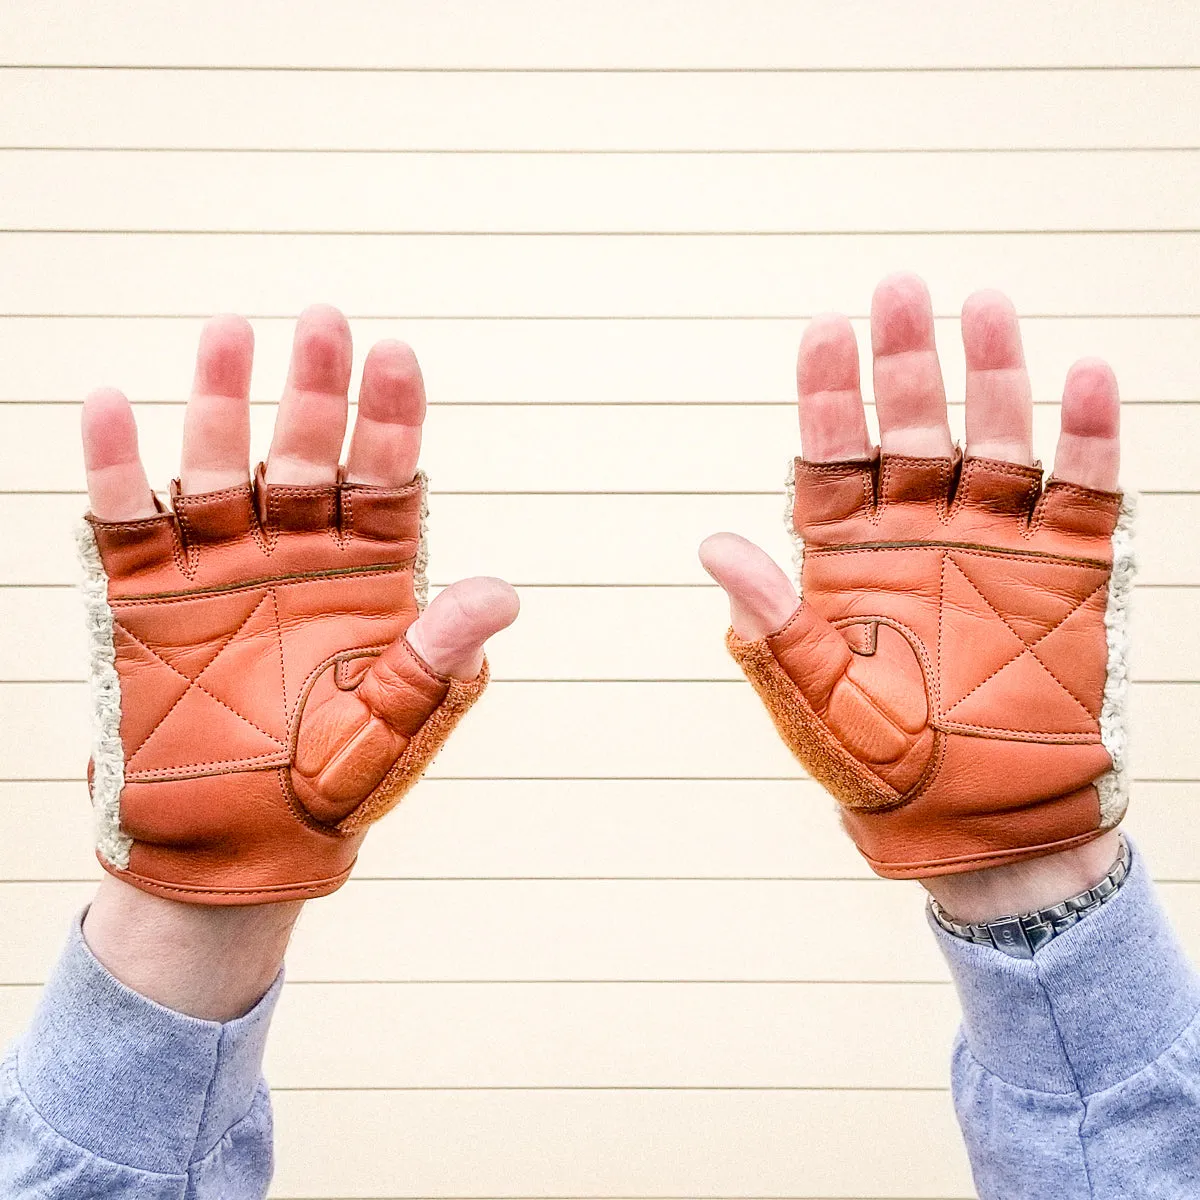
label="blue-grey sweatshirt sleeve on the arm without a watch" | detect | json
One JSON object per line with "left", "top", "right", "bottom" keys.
{"left": 0, "top": 920, "right": 282, "bottom": 1200}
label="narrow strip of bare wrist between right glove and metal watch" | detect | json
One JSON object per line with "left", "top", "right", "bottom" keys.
{"left": 922, "top": 829, "right": 1121, "bottom": 924}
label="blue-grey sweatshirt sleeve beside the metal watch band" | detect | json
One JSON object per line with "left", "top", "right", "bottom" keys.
{"left": 930, "top": 850, "right": 1200, "bottom": 1200}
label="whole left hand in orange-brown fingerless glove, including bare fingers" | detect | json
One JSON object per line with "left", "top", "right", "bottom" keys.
{"left": 83, "top": 307, "right": 517, "bottom": 905}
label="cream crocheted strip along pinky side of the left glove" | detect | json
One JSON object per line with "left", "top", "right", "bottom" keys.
{"left": 76, "top": 521, "right": 133, "bottom": 870}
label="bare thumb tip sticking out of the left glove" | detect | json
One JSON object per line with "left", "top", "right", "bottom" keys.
{"left": 407, "top": 576, "right": 521, "bottom": 679}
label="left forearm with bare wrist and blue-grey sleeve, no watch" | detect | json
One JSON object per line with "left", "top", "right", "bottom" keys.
{"left": 0, "top": 878, "right": 290, "bottom": 1200}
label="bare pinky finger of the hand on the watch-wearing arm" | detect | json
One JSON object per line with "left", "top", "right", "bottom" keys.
{"left": 1054, "top": 359, "right": 1121, "bottom": 492}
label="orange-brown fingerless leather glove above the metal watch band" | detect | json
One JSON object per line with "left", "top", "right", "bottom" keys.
{"left": 728, "top": 455, "right": 1133, "bottom": 878}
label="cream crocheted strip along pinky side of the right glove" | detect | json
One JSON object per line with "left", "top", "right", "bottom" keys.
{"left": 1096, "top": 493, "right": 1138, "bottom": 829}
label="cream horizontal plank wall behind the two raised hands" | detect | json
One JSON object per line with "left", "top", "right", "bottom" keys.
{"left": 0, "top": 0, "right": 1200, "bottom": 1200}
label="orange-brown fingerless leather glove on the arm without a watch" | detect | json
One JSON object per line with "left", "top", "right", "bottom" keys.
{"left": 79, "top": 467, "right": 486, "bottom": 905}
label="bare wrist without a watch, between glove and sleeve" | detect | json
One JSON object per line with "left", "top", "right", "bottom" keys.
{"left": 83, "top": 876, "right": 304, "bottom": 1021}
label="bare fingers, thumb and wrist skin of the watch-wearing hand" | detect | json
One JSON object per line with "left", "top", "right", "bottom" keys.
{"left": 701, "top": 275, "right": 1118, "bottom": 902}
